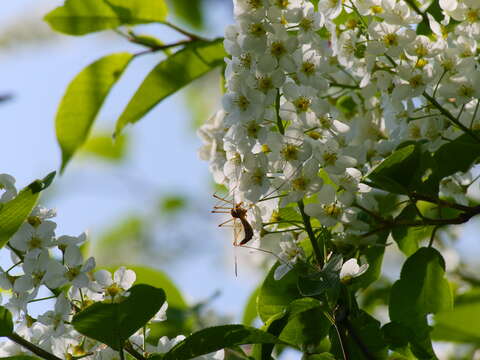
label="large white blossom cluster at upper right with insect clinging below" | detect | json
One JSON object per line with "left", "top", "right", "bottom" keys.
{"left": 199, "top": 0, "right": 480, "bottom": 272}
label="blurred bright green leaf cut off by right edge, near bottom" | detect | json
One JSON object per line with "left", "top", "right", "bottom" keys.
{"left": 432, "top": 288, "right": 480, "bottom": 345}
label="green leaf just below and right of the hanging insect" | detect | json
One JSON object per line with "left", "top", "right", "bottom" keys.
{"left": 257, "top": 262, "right": 302, "bottom": 322}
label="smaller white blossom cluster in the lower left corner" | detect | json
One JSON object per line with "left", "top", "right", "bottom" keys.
{"left": 0, "top": 174, "right": 223, "bottom": 360}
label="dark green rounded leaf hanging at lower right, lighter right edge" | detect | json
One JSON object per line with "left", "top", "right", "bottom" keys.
{"left": 389, "top": 248, "right": 453, "bottom": 325}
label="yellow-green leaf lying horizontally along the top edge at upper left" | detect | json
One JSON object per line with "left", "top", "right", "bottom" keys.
{"left": 45, "top": 0, "right": 167, "bottom": 35}
